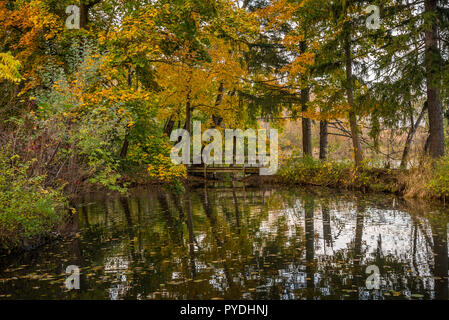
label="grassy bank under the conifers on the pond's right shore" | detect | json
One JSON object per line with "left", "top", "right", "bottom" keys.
{"left": 278, "top": 157, "right": 449, "bottom": 201}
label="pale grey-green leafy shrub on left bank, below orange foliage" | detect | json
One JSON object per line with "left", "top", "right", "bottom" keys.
{"left": 32, "top": 42, "right": 126, "bottom": 192}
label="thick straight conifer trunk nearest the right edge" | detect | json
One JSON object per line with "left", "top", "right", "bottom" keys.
{"left": 424, "top": 0, "right": 444, "bottom": 158}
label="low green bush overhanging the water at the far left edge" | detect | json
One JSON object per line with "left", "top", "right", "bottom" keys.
{"left": 0, "top": 148, "right": 67, "bottom": 250}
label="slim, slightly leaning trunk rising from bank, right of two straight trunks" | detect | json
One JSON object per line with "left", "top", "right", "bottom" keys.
{"left": 345, "top": 32, "right": 363, "bottom": 167}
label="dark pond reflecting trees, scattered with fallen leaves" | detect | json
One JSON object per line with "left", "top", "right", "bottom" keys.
{"left": 0, "top": 183, "right": 449, "bottom": 300}
